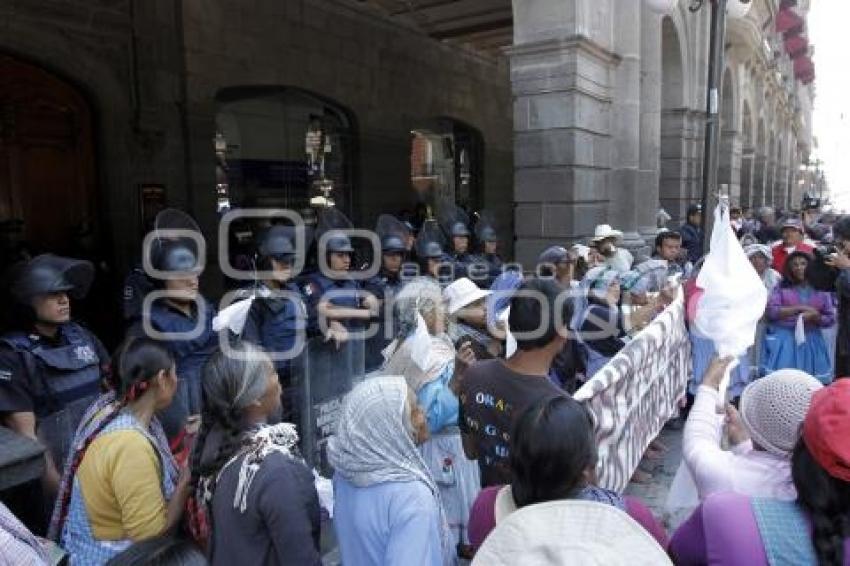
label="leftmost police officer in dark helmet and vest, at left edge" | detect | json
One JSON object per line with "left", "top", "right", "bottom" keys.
{"left": 0, "top": 254, "right": 109, "bottom": 495}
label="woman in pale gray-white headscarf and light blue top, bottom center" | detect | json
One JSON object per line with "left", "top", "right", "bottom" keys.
{"left": 328, "top": 376, "right": 456, "bottom": 566}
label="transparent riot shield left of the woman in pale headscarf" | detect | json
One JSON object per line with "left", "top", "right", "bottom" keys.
{"left": 293, "top": 336, "right": 365, "bottom": 477}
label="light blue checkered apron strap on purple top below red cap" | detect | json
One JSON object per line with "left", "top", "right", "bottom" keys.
{"left": 752, "top": 498, "right": 818, "bottom": 566}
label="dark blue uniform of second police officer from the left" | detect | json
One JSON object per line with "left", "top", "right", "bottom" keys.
{"left": 129, "top": 299, "right": 218, "bottom": 438}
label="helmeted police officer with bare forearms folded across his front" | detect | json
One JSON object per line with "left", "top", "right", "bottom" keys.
{"left": 304, "top": 230, "right": 378, "bottom": 345}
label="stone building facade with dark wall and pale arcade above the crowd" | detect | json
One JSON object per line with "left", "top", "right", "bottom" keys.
{"left": 0, "top": 0, "right": 813, "bottom": 276}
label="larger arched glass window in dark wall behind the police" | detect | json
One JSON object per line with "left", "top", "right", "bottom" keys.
{"left": 215, "top": 87, "right": 355, "bottom": 222}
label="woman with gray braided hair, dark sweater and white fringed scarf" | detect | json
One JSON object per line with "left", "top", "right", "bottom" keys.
{"left": 190, "top": 342, "right": 321, "bottom": 565}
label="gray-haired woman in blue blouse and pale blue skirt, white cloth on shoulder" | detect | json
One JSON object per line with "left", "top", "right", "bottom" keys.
{"left": 383, "top": 277, "right": 481, "bottom": 556}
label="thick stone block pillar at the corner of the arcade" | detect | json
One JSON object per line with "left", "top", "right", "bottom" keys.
{"left": 509, "top": 0, "right": 618, "bottom": 265}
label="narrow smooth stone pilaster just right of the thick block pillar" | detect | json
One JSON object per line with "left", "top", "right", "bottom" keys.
{"left": 608, "top": 2, "right": 648, "bottom": 251}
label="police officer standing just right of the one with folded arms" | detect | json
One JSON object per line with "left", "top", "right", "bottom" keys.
{"left": 365, "top": 234, "right": 407, "bottom": 372}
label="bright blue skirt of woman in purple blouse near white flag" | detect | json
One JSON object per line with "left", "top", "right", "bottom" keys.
{"left": 761, "top": 325, "right": 832, "bottom": 385}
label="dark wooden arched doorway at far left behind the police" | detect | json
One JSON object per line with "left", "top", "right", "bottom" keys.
{"left": 0, "top": 55, "right": 100, "bottom": 267}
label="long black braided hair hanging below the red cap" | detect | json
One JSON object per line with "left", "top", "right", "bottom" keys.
{"left": 791, "top": 438, "right": 850, "bottom": 566}
